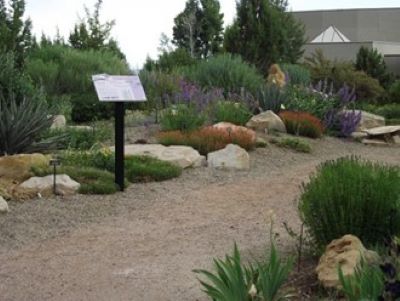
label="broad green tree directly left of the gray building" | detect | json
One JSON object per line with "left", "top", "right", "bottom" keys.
{"left": 224, "top": 0, "right": 305, "bottom": 74}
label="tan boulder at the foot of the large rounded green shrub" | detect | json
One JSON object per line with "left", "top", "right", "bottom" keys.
{"left": 316, "top": 235, "right": 379, "bottom": 288}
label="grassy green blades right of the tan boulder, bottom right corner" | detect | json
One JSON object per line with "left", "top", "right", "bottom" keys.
{"left": 338, "top": 262, "right": 384, "bottom": 301}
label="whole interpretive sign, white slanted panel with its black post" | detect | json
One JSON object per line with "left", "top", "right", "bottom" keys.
{"left": 92, "top": 74, "right": 146, "bottom": 191}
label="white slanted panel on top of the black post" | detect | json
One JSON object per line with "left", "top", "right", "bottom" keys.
{"left": 92, "top": 74, "right": 147, "bottom": 102}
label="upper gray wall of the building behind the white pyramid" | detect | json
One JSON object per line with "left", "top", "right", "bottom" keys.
{"left": 293, "top": 7, "right": 400, "bottom": 42}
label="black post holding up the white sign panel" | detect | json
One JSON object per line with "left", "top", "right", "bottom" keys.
{"left": 115, "top": 102, "right": 125, "bottom": 191}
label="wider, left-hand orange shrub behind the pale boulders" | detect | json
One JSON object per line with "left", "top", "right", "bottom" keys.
{"left": 157, "top": 126, "right": 255, "bottom": 155}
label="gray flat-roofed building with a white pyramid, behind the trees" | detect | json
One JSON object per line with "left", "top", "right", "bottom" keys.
{"left": 293, "top": 7, "right": 400, "bottom": 75}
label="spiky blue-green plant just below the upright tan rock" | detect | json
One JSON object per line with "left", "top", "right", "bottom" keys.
{"left": 256, "top": 84, "right": 289, "bottom": 113}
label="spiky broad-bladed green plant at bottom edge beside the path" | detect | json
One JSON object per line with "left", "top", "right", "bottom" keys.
{"left": 194, "top": 244, "right": 292, "bottom": 301}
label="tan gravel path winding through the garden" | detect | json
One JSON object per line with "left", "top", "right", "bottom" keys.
{"left": 0, "top": 138, "right": 400, "bottom": 301}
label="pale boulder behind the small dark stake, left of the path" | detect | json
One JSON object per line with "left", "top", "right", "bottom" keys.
{"left": 18, "top": 175, "right": 81, "bottom": 196}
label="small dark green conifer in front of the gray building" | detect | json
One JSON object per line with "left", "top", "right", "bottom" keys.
{"left": 355, "top": 46, "right": 391, "bottom": 87}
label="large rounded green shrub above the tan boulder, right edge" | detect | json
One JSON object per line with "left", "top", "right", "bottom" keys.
{"left": 299, "top": 157, "right": 400, "bottom": 248}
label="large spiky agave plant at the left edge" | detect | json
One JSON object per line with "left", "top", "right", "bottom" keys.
{"left": 0, "top": 94, "right": 55, "bottom": 156}
